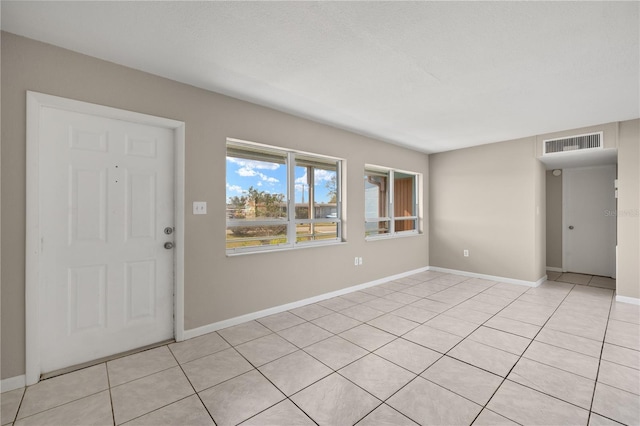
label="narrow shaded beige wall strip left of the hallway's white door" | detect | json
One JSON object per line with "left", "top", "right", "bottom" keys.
{"left": 546, "top": 170, "right": 562, "bottom": 268}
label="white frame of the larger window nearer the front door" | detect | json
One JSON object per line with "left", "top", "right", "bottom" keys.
{"left": 225, "top": 138, "right": 345, "bottom": 256}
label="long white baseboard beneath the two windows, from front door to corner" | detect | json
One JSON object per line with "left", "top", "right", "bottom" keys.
{"left": 184, "top": 266, "right": 429, "bottom": 339}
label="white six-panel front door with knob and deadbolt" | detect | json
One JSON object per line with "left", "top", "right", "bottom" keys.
{"left": 39, "top": 108, "right": 174, "bottom": 372}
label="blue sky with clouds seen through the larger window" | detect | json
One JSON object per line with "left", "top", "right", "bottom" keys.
{"left": 227, "top": 157, "right": 335, "bottom": 203}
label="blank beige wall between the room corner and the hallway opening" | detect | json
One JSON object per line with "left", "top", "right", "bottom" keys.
{"left": 429, "top": 137, "right": 546, "bottom": 281}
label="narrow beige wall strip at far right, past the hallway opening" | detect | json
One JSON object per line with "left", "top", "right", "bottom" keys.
{"left": 616, "top": 120, "right": 640, "bottom": 298}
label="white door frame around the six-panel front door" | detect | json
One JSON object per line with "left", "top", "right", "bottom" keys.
{"left": 25, "top": 91, "right": 185, "bottom": 385}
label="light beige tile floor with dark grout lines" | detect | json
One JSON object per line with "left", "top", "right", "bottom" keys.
{"left": 2, "top": 271, "right": 640, "bottom": 426}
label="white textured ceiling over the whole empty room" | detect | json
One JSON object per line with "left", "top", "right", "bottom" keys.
{"left": 1, "top": 0, "right": 640, "bottom": 152}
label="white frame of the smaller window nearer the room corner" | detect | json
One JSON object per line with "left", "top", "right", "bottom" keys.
{"left": 363, "top": 164, "right": 422, "bottom": 241}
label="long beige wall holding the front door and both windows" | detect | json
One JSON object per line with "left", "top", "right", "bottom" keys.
{"left": 1, "top": 33, "right": 429, "bottom": 378}
